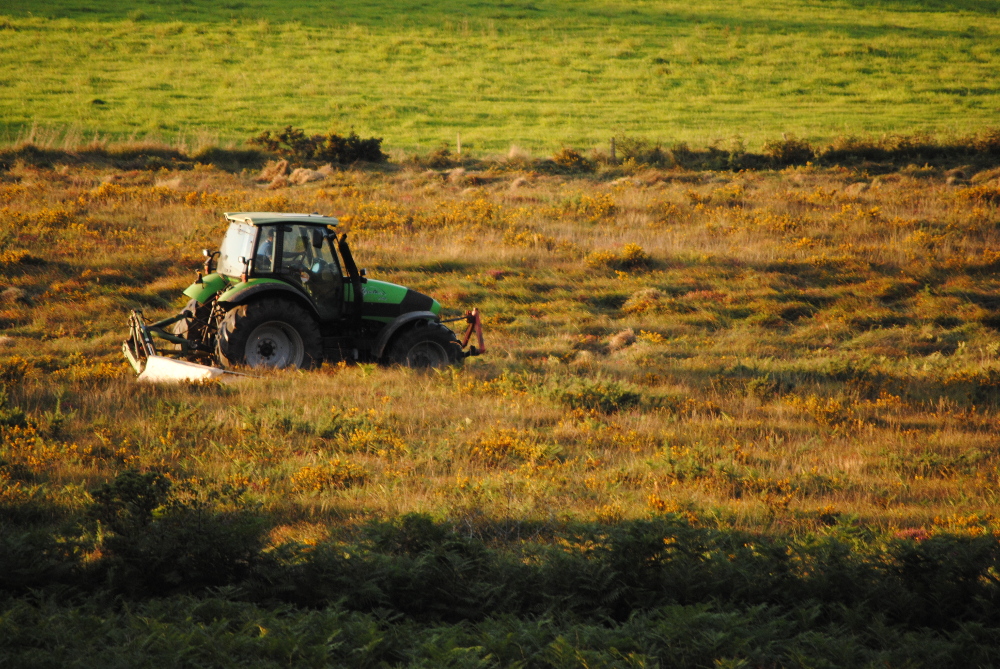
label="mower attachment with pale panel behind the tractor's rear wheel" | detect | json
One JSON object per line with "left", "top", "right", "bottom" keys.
{"left": 122, "top": 311, "right": 234, "bottom": 383}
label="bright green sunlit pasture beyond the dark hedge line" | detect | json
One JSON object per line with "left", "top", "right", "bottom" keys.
{"left": 0, "top": 0, "right": 1000, "bottom": 154}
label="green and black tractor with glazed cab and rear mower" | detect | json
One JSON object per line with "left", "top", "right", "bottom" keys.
{"left": 122, "top": 212, "right": 486, "bottom": 381}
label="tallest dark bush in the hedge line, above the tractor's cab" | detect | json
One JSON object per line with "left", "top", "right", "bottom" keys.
{"left": 249, "top": 125, "right": 387, "bottom": 165}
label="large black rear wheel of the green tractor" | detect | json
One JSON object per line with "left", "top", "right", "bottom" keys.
{"left": 215, "top": 297, "right": 323, "bottom": 369}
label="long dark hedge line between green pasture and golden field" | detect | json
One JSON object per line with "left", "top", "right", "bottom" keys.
{"left": 0, "top": 126, "right": 1000, "bottom": 176}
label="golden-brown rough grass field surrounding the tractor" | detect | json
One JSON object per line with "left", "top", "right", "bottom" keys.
{"left": 0, "top": 158, "right": 1000, "bottom": 536}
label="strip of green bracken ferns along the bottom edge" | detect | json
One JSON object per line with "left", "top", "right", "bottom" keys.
{"left": 0, "top": 596, "right": 998, "bottom": 667}
